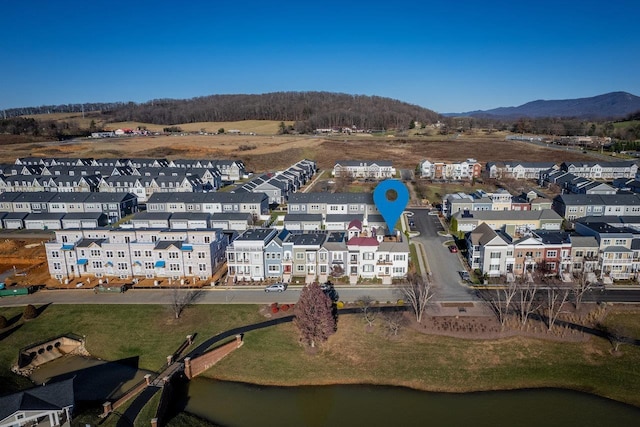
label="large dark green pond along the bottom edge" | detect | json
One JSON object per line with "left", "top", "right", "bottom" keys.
{"left": 184, "top": 378, "right": 640, "bottom": 427}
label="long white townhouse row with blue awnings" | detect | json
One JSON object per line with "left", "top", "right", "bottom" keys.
{"left": 45, "top": 228, "right": 227, "bottom": 281}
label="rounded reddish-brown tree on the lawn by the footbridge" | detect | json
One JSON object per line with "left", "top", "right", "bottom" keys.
{"left": 293, "top": 283, "right": 337, "bottom": 348}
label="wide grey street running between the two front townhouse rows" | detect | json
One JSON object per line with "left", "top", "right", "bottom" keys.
{"left": 409, "top": 209, "right": 477, "bottom": 301}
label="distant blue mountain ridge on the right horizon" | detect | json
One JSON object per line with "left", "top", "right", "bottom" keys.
{"left": 443, "top": 92, "right": 640, "bottom": 119}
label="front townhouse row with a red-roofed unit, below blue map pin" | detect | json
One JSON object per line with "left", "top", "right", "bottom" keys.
{"left": 227, "top": 228, "right": 409, "bottom": 284}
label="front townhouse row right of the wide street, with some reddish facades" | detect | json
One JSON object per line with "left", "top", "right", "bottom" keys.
{"left": 466, "top": 217, "right": 640, "bottom": 282}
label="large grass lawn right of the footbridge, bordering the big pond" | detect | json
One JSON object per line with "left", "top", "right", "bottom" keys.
{"left": 204, "top": 314, "right": 640, "bottom": 406}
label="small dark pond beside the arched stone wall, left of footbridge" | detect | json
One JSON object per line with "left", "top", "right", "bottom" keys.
{"left": 29, "top": 355, "right": 147, "bottom": 401}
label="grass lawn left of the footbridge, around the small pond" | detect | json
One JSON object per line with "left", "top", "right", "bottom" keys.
{"left": 0, "top": 305, "right": 265, "bottom": 394}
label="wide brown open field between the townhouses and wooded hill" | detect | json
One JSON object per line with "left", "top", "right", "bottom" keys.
{"left": 0, "top": 127, "right": 589, "bottom": 172}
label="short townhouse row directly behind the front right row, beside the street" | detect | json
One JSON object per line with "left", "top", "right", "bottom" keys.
{"left": 441, "top": 189, "right": 551, "bottom": 218}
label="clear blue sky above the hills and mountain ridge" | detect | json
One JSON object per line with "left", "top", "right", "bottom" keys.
{"left": 0, "top": 0, "right": 640, "bottom": 113}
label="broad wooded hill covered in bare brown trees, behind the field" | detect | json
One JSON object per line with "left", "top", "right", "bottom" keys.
{"left": 108, "top": 92, "right": 440, "bottom": 133}
